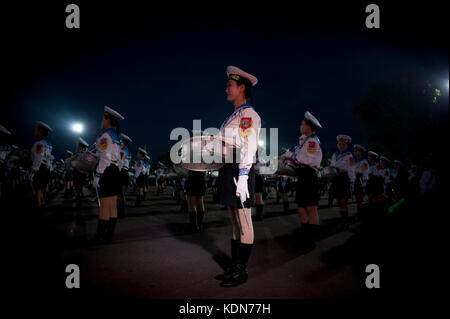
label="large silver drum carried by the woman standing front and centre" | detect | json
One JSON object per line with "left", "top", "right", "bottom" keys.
{"left": 179, "top": 136, "right": 236, "bottom": 172}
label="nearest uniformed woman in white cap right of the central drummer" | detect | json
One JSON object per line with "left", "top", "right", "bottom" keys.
{"left": 286, "top": 111, "right": 322, "bottom": 249}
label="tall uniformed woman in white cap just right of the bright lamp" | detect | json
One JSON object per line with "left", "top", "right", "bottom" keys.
{"left": 93, "top": 106, "right": 124, "bottom": 243}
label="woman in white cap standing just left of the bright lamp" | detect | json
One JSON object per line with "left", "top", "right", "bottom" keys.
{"left": 30, "top": 121, "right": 53, "bottom": 214}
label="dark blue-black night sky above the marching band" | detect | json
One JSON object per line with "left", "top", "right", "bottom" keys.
{"left": 0, "top": 1, "right": 448, "bottom": 159}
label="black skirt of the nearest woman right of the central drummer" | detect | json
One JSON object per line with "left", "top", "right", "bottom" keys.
{"left": 295, "top": 166, "right": 319, "bottom": 207}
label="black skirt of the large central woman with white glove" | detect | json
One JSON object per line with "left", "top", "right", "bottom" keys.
{"left": 218, "top": 163, "right": 255, "bottom": 208}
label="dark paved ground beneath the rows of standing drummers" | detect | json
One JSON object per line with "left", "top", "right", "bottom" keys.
{"left": 4, "top": 184, "right": 418, "bottom": 299}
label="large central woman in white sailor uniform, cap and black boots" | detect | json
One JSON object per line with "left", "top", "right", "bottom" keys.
{"left": 218, "top": 66, "right": 261, "bottom": 287}
